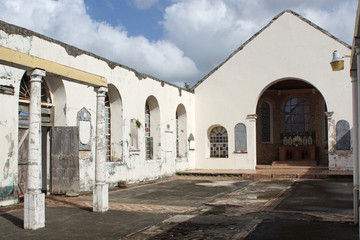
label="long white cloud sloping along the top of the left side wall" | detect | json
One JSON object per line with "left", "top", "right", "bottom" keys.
{"left": 0, "top": 0, "right": 199, "bottom": 81}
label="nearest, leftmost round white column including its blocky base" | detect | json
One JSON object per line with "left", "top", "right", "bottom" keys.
{"left": 24, "top": 69, "right": 45, "bottom": 229}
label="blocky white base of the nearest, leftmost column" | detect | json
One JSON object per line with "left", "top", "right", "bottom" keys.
{"left": 24, "top": 193, "right": 45, "bottom": 230}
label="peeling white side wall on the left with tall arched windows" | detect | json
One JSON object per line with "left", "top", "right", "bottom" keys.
{"left": 0, "top": 22, "right": 195, "bottom": 197}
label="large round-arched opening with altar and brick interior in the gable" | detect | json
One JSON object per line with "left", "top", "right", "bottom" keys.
{"left": 256, "top": 79, "right": 328, "bottom": 166}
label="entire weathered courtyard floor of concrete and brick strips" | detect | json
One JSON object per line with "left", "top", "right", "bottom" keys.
{"left": 0, "top": 176, "right": 359, "bottom": 239}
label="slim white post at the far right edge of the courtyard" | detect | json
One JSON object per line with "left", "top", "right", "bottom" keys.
{"left": 351, "top": 70, "right": 359, "bottom": 224}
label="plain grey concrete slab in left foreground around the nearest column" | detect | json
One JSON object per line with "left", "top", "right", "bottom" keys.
{"left": 0, "top": 207, "right": 168, "bottom": 239}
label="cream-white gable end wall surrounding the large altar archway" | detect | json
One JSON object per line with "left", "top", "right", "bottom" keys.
{"left": 195, "top": 12, "right": 352, "bottom": 169}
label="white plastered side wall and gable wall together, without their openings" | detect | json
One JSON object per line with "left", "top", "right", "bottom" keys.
{"left": 0, "top": 9, "right": 352, "bottom": 206}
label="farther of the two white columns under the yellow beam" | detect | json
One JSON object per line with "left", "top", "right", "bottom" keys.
{"left": 93, "top": 87, "right": 109, "bottom": 212}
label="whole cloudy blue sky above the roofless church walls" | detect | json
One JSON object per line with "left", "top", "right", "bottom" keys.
{"left": 0, "top": 0, "right": 358, "bottom": 86}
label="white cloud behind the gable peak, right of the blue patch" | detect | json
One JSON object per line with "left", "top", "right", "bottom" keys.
{"left": 162, "top": 0, "right": 357, "bottom": 84}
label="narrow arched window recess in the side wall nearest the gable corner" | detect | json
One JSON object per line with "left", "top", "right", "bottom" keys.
{"left": 175, "top": 104, "right": 187, "bottom": 158}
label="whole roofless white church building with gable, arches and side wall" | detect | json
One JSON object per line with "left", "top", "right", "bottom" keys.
{"left": 0, "top": 10, "right": 353, "bottom": 208}
